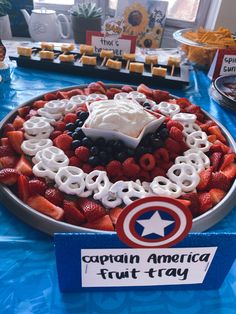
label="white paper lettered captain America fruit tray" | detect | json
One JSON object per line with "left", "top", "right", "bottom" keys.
{"left": 81, "top": 247, "right": 217, "bottom": 287}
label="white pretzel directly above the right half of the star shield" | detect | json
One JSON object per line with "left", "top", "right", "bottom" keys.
{"left": 150, "top": 176, "right": 182, "bottom": 198}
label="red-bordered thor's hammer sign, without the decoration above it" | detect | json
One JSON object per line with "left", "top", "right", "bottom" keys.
{"left": 86, "top": 31, "right": 136, "bottom": 56}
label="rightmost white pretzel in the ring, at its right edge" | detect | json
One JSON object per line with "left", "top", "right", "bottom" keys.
{"left": 186, "top": 131, "right": 211, "bottom": 152}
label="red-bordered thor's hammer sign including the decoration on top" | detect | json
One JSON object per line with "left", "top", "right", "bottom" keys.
{"left": 86, "top": 18, "right": 137, "bottom": 56}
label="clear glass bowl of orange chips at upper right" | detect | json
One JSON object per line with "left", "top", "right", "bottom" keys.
{"left": 173, "top": 27, "right": 236, "bottom": 69}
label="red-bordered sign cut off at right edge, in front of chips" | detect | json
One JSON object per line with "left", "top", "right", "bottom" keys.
{"left": 208, "top": 49, "right": 236, "bottom": 80}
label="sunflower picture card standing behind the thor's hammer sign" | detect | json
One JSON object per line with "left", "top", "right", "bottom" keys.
{"left": 116, "top": 0, "right": 168, "bottom": 48}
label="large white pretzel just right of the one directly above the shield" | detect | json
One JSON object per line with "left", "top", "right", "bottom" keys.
{"left": 167, "top": 164, "right": 200, "bottom": 192}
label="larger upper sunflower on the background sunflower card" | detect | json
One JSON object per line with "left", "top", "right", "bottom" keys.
{"left": 124, "top": 3, "right": 149, "bottom": 35}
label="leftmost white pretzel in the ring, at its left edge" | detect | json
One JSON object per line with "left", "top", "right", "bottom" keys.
{"left": 21, "top": 138, "right": 53, "bottom": 156}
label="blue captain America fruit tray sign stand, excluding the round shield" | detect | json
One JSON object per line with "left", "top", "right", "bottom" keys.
{"left": 55, "top": 233, "right": 236, "bottom": 292}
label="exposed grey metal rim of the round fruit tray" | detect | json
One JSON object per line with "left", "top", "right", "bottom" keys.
{"left": 0, "top": 84, "right": 236, "bottom": 235}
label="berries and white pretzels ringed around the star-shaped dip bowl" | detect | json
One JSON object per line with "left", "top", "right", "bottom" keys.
{"left": 0, "top": 82, "right": 236, "bottom": 231}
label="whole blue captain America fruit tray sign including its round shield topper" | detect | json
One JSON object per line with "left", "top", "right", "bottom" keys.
{"left": 55, "top": 197, "right": 236, "bottom": 292}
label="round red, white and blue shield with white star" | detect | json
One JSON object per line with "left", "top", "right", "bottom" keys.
{"left": 116, "top": 196, "right": 192, "bottom": 248}
